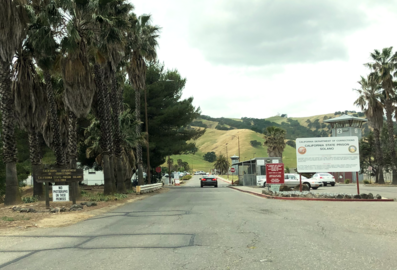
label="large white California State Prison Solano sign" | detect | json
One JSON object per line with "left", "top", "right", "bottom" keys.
{"left": 296, "top": 136, "right": 360, "bottom": 173}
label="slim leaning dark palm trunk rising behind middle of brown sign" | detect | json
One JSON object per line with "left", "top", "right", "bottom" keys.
{"left": 44, "top": 70, "right": 65, "bottom": 167}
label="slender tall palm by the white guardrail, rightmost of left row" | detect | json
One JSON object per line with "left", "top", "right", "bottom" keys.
{"left": 127, "top": 15, "right": 160, "bottom": 185}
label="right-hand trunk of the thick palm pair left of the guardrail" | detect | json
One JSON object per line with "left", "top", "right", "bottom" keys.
{"left": 110, "top": 71, "right": 127, "bottom": 193}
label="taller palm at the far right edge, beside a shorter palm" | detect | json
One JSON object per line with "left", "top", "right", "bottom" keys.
{"left": 365, "top": 47, "right": 397, "bottom": 184}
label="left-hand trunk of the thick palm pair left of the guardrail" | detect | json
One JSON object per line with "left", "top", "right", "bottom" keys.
{"left": 94, "top": 64, "right": 114, "bottom": 195}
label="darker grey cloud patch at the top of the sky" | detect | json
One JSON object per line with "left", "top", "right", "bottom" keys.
{"left": 189, "top": 0, "right": 369, "bottom": 66}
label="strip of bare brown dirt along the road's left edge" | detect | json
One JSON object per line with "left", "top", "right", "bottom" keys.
{"left": 0, "top": 188, "right": 169, "bottom": 235}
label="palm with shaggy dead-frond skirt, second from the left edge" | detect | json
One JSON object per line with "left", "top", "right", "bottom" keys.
{"left": 12, "top": 42, "right": 47, "bottom": 198}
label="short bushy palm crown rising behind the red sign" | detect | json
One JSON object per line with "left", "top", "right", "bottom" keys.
{"left": 264, "top": 126, "right": 287, "bottom": 163}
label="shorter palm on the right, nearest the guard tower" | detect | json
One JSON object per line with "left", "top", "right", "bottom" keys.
{"left": 354, "top": 77, "right": 385, "bottom": 184}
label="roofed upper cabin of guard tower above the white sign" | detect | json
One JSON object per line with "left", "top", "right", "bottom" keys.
{"left": 324, "top": 115, "right": 368, "bottom": 140}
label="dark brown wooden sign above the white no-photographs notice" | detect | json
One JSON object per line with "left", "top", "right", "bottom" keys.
{"left": 37, "top": 169, "right": 84, "bottom": 182}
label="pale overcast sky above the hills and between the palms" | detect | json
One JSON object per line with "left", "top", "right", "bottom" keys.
{"left": 131, "top": 0, "right": 397, "bottom": 118}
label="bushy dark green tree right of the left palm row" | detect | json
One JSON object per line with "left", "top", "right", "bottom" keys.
{"left": 124, "top": 63, "right": 205, "bottom": 168}
